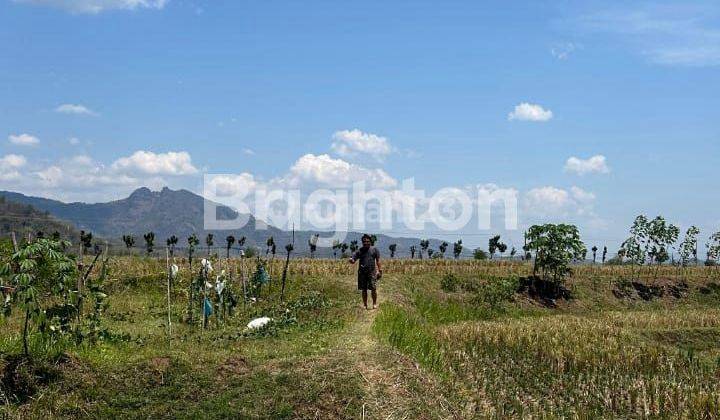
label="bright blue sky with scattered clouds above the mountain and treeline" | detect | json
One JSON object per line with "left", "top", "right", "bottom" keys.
{"left": 0, "top": 0, "right": 720, "bottom": 249}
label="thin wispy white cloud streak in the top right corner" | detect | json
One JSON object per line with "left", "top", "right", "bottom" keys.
{"left": 577, "top": 2, "right": 720, "bottom": 67}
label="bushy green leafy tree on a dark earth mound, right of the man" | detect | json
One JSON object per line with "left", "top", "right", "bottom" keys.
{"left": 527, "top": 223, "right": 587, "bottom": 284}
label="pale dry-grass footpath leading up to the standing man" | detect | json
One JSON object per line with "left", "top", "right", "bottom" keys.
{"left": 331, "top": 278, "right": 454, "bottom": 419}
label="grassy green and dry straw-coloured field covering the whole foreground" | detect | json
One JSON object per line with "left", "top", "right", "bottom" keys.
{"left": 0, "top": 257, "right": 720, "bottom": 419}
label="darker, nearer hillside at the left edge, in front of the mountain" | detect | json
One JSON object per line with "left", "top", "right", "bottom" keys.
{"left": 0, "top": 196, "right": 80, "bottom": 243}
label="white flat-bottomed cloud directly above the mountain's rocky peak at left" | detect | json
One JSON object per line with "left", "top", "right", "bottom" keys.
{"left": 111, "top": 150, "right": 198, "bottom": 175}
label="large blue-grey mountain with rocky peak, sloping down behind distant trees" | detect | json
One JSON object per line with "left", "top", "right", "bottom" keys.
{"left": 0, "top": 187, "right": 450, "bottom": 256}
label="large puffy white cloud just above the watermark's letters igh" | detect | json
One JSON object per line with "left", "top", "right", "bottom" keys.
{"left": 285, "top": 153, "right": 397, "bottom": 188}
